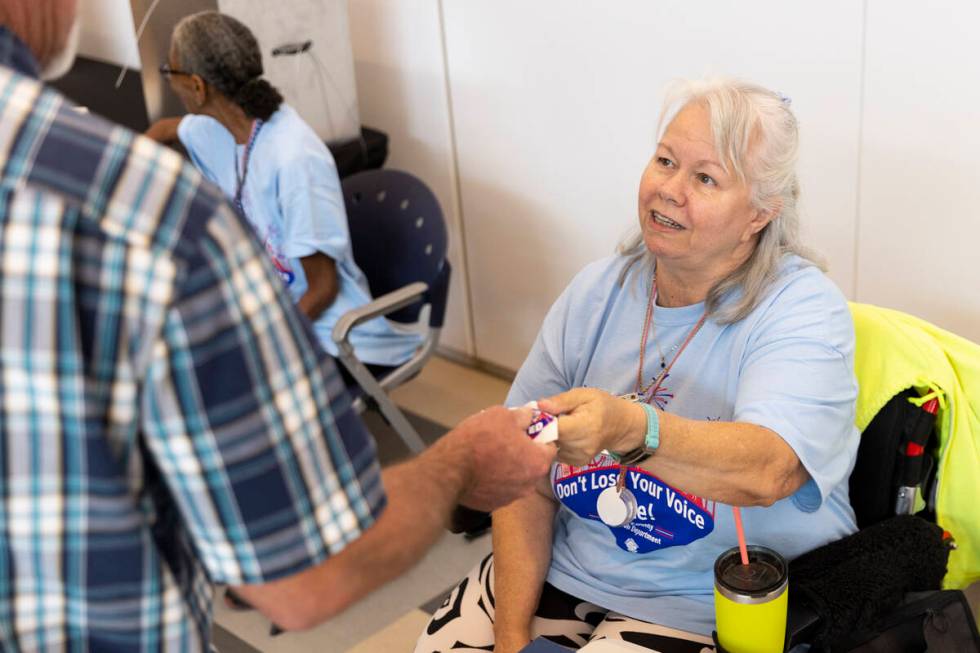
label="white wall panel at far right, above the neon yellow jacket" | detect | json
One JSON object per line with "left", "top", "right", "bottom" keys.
{"left": 857, "top": 0, "right": 980, "bottom": 342}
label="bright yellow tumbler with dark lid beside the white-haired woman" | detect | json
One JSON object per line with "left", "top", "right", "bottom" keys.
{"left": 715, "top": 545, "right": 789, "bottom": 653}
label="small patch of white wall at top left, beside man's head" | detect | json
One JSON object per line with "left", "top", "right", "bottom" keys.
{"left": 78, "top": 0, "right": 140, "bottom": 70}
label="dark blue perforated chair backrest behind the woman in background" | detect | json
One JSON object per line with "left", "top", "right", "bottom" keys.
{"left": 342, "top": 170, "right": 449, "bottom": 327}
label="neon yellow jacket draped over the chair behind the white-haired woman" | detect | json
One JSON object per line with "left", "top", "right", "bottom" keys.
{"left": 850, "top": 303, "right": 980, "bottom": 589}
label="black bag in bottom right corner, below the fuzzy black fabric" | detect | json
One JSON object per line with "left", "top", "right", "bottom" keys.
{"left": 831, "top": 590, "right": 980, "bottom": 653}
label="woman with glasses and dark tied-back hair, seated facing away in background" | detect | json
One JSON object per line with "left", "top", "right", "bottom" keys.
{"left": 147, "top": 11, "right": 421, "bottom": 376}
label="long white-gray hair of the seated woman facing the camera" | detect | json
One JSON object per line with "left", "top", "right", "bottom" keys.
{"left": 619, "top": 79, "right": 824, "bottom": 324}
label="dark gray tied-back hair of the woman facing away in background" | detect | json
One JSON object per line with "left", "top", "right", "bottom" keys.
{"left": 171, "top": 11, "right": 282, "bottom": 120}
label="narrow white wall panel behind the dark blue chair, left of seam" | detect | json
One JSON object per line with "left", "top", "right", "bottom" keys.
{"left": 350, "top": 0, "right": 474, "bottom": 356}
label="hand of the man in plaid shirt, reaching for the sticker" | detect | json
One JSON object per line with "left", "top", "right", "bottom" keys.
{"left": 436, "top": 406, "right": 555, "bottom": 512}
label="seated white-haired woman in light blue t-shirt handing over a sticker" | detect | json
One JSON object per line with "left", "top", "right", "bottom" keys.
{"left": 416, "top": 80, "right": 858, "bottom": 653}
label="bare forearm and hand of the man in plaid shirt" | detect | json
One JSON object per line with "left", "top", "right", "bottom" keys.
{"left": 229, "top": 406, "right": 555, "bottom": 629}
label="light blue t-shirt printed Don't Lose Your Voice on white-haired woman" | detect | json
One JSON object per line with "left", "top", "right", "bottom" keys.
{"left": 507, "top": 256, "right": 858, "bottom": 634}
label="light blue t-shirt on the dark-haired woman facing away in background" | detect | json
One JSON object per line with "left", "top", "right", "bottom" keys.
{"left": 177, "top": 104, "right": 421, "bottom": 365}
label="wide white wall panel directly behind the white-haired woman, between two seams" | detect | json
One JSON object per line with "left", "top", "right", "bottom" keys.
{"left": 443, "top": 0, "right": 863, "bottom": 369}
